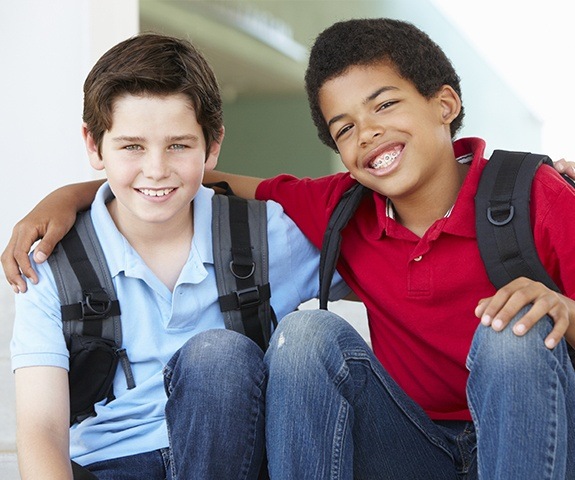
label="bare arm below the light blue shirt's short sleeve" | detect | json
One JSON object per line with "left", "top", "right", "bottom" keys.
{"left": 15, "top": 367, "right": 72, "bottom": 480}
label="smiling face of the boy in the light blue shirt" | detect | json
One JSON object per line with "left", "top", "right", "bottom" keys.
{"left": 83, "top": 94, "right": 223, "bottom": 232}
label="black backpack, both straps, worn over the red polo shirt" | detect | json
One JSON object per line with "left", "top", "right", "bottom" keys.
{"left": 319, "top": 150, "right": 575, "bottom": 366}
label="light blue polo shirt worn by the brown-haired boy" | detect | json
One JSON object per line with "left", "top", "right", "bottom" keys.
{"left": 11, "top": 184, "right": 349, "bottom": 465}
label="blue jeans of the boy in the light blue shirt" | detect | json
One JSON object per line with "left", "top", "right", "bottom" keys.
{"left": 84, "top": 329, "right": 267, "bottom": 480}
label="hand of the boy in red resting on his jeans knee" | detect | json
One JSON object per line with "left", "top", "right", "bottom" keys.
{"left": 475, "top": 277, "right": 575, "bottom": 349}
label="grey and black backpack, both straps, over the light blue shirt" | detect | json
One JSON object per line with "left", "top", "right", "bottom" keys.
{"left": 49, "top": 191, "right": 277, "bottom": 424}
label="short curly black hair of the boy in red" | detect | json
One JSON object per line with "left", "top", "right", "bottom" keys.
{"left": 305, "top": 18, "right": 465, "bottom": 151}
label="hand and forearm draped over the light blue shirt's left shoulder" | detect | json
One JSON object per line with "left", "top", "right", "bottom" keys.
{"left": 2, "top": 180, "right": 103, "bottom": 293}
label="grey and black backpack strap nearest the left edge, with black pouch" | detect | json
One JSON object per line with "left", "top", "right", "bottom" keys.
{"left": 48, "top": 212, "right": 135, "bottom": 423}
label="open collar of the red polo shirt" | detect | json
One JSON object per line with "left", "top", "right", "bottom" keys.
{"left": 373, "top": 137, "right": 486, "bottom": 238}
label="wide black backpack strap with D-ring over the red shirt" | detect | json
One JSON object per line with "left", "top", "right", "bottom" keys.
{"left": 475, "top": 150, "right": 559, "bottom": 291}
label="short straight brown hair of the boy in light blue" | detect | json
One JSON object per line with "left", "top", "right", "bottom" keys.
{"left": 83, "top": 33, "right": 223, "bottom": 158}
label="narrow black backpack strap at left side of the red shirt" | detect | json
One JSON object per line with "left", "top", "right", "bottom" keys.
{"left": 319, "top": 183, "right": 370, "bottom": 310}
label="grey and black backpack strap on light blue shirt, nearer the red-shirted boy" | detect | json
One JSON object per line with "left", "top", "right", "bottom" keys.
{"left": 212, "top": 194, "right": 276, "bottom": 350}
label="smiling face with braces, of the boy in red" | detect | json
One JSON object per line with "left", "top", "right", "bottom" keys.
{"left": 319, "top": 63, "right": 461, "bottom": 200}
